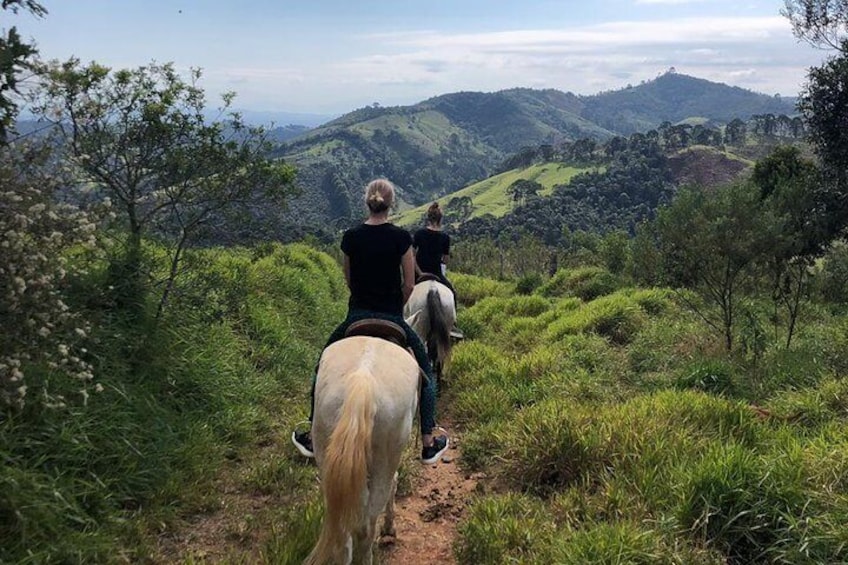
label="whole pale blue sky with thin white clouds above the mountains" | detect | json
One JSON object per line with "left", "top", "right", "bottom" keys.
{"left": 2, "top": 0, "right": 827, "bottom": 114}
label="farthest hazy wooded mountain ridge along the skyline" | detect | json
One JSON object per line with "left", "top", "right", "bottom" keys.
{"left": 275, "top": 72, "right": 795, "bottom": 231}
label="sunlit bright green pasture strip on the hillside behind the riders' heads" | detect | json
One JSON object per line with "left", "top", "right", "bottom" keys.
{"left": 393, "top": 163, "right": 600, "bottom": 226}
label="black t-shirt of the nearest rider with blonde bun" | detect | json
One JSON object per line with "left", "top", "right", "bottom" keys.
{"left": 342, "top": 224, "right": 412, "bottom": 315}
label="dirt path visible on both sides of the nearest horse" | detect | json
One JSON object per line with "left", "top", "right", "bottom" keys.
{"left": 149, "top": 428, "right": 480, "bottom": 565}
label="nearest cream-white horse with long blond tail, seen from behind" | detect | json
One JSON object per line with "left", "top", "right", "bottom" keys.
{"left": 304, "top": 336, "right": 420, "bottom": 565}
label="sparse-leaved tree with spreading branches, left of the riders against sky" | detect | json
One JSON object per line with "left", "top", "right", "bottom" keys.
{"left": 35, "top": 59, "right": 294, "bottom": 316}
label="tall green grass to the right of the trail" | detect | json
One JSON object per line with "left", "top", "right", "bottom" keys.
{"left": 447, "top": 268, "right": 848, "bottom": 565}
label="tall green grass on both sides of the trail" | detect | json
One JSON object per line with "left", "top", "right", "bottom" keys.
{"left": 11, "top": 241, "right": 848, "bottom": 563}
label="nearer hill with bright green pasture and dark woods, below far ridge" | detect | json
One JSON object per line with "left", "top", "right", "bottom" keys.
{"left": 393, "top": 115, "right": 808, "bottom": 244}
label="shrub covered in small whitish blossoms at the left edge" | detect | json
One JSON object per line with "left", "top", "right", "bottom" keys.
{"left": 0, "top": 140, "right": 101, "bottom": 407}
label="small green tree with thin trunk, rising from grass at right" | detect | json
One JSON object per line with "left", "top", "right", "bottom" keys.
{"left": 655, "top": 182, "right": 778, "bottom": 351}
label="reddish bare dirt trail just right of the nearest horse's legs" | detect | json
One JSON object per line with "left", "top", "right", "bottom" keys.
{"left": 380, "top": 436, "right": 478, "bottom": 565}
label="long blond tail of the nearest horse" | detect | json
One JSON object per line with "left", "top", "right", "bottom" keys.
{"left": 304, "top": 370, "right": 375, "bottom": 565}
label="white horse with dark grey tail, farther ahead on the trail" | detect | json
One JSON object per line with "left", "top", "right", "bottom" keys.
{"left": 403, "top": 280, "right": 456, "bottom": 383}
